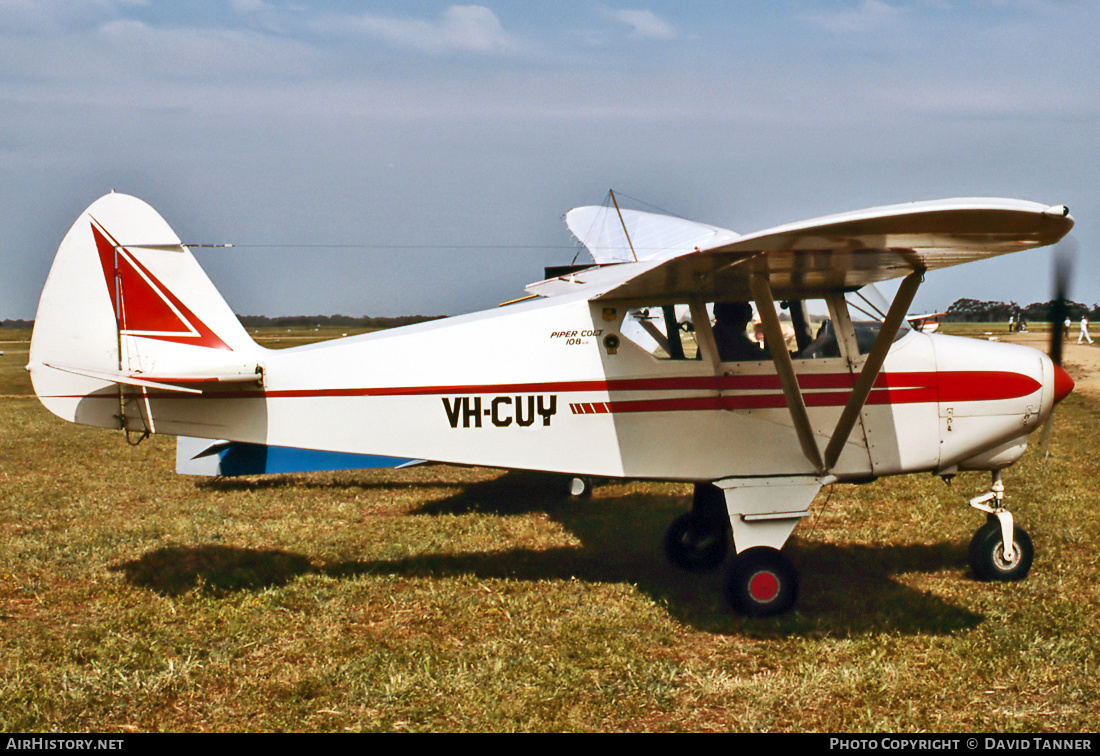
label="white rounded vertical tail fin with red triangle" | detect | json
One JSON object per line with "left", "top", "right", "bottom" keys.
{"left": 29, "top": 193, "right": 262, "bottom": 428}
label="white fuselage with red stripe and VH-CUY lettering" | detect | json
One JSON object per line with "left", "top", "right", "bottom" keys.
{"left": 53, "top": 297, "right": 1054, "bottom": 481}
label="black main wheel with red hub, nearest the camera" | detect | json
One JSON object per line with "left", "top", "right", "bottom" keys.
{"left": 726, "top": 546, "right": 799, "bottom": 617}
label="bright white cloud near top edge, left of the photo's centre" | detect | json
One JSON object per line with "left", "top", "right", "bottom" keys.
{"left": 328, "top": 6, "right": 523, "bottom": 53}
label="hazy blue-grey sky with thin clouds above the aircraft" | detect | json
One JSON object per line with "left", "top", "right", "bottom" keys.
{"left": 0, "top": 0, "right": 1100, "bottom": 319}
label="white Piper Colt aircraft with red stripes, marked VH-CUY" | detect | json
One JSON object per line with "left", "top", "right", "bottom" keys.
{"left": 29, "top": 193, "right": 1074, "bottom": 616}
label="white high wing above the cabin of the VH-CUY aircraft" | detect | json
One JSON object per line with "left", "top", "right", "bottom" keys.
{"left": 536, "top": 198, "right": 1074, "bottom": 303}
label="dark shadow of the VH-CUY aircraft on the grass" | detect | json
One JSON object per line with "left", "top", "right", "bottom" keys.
{"left": 111, "top": 473, "right": 983, "bottom": 635}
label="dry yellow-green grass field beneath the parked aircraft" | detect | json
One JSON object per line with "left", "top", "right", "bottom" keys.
{"left": 0, "top": 325, "right": 1100, "bottom": 732}
